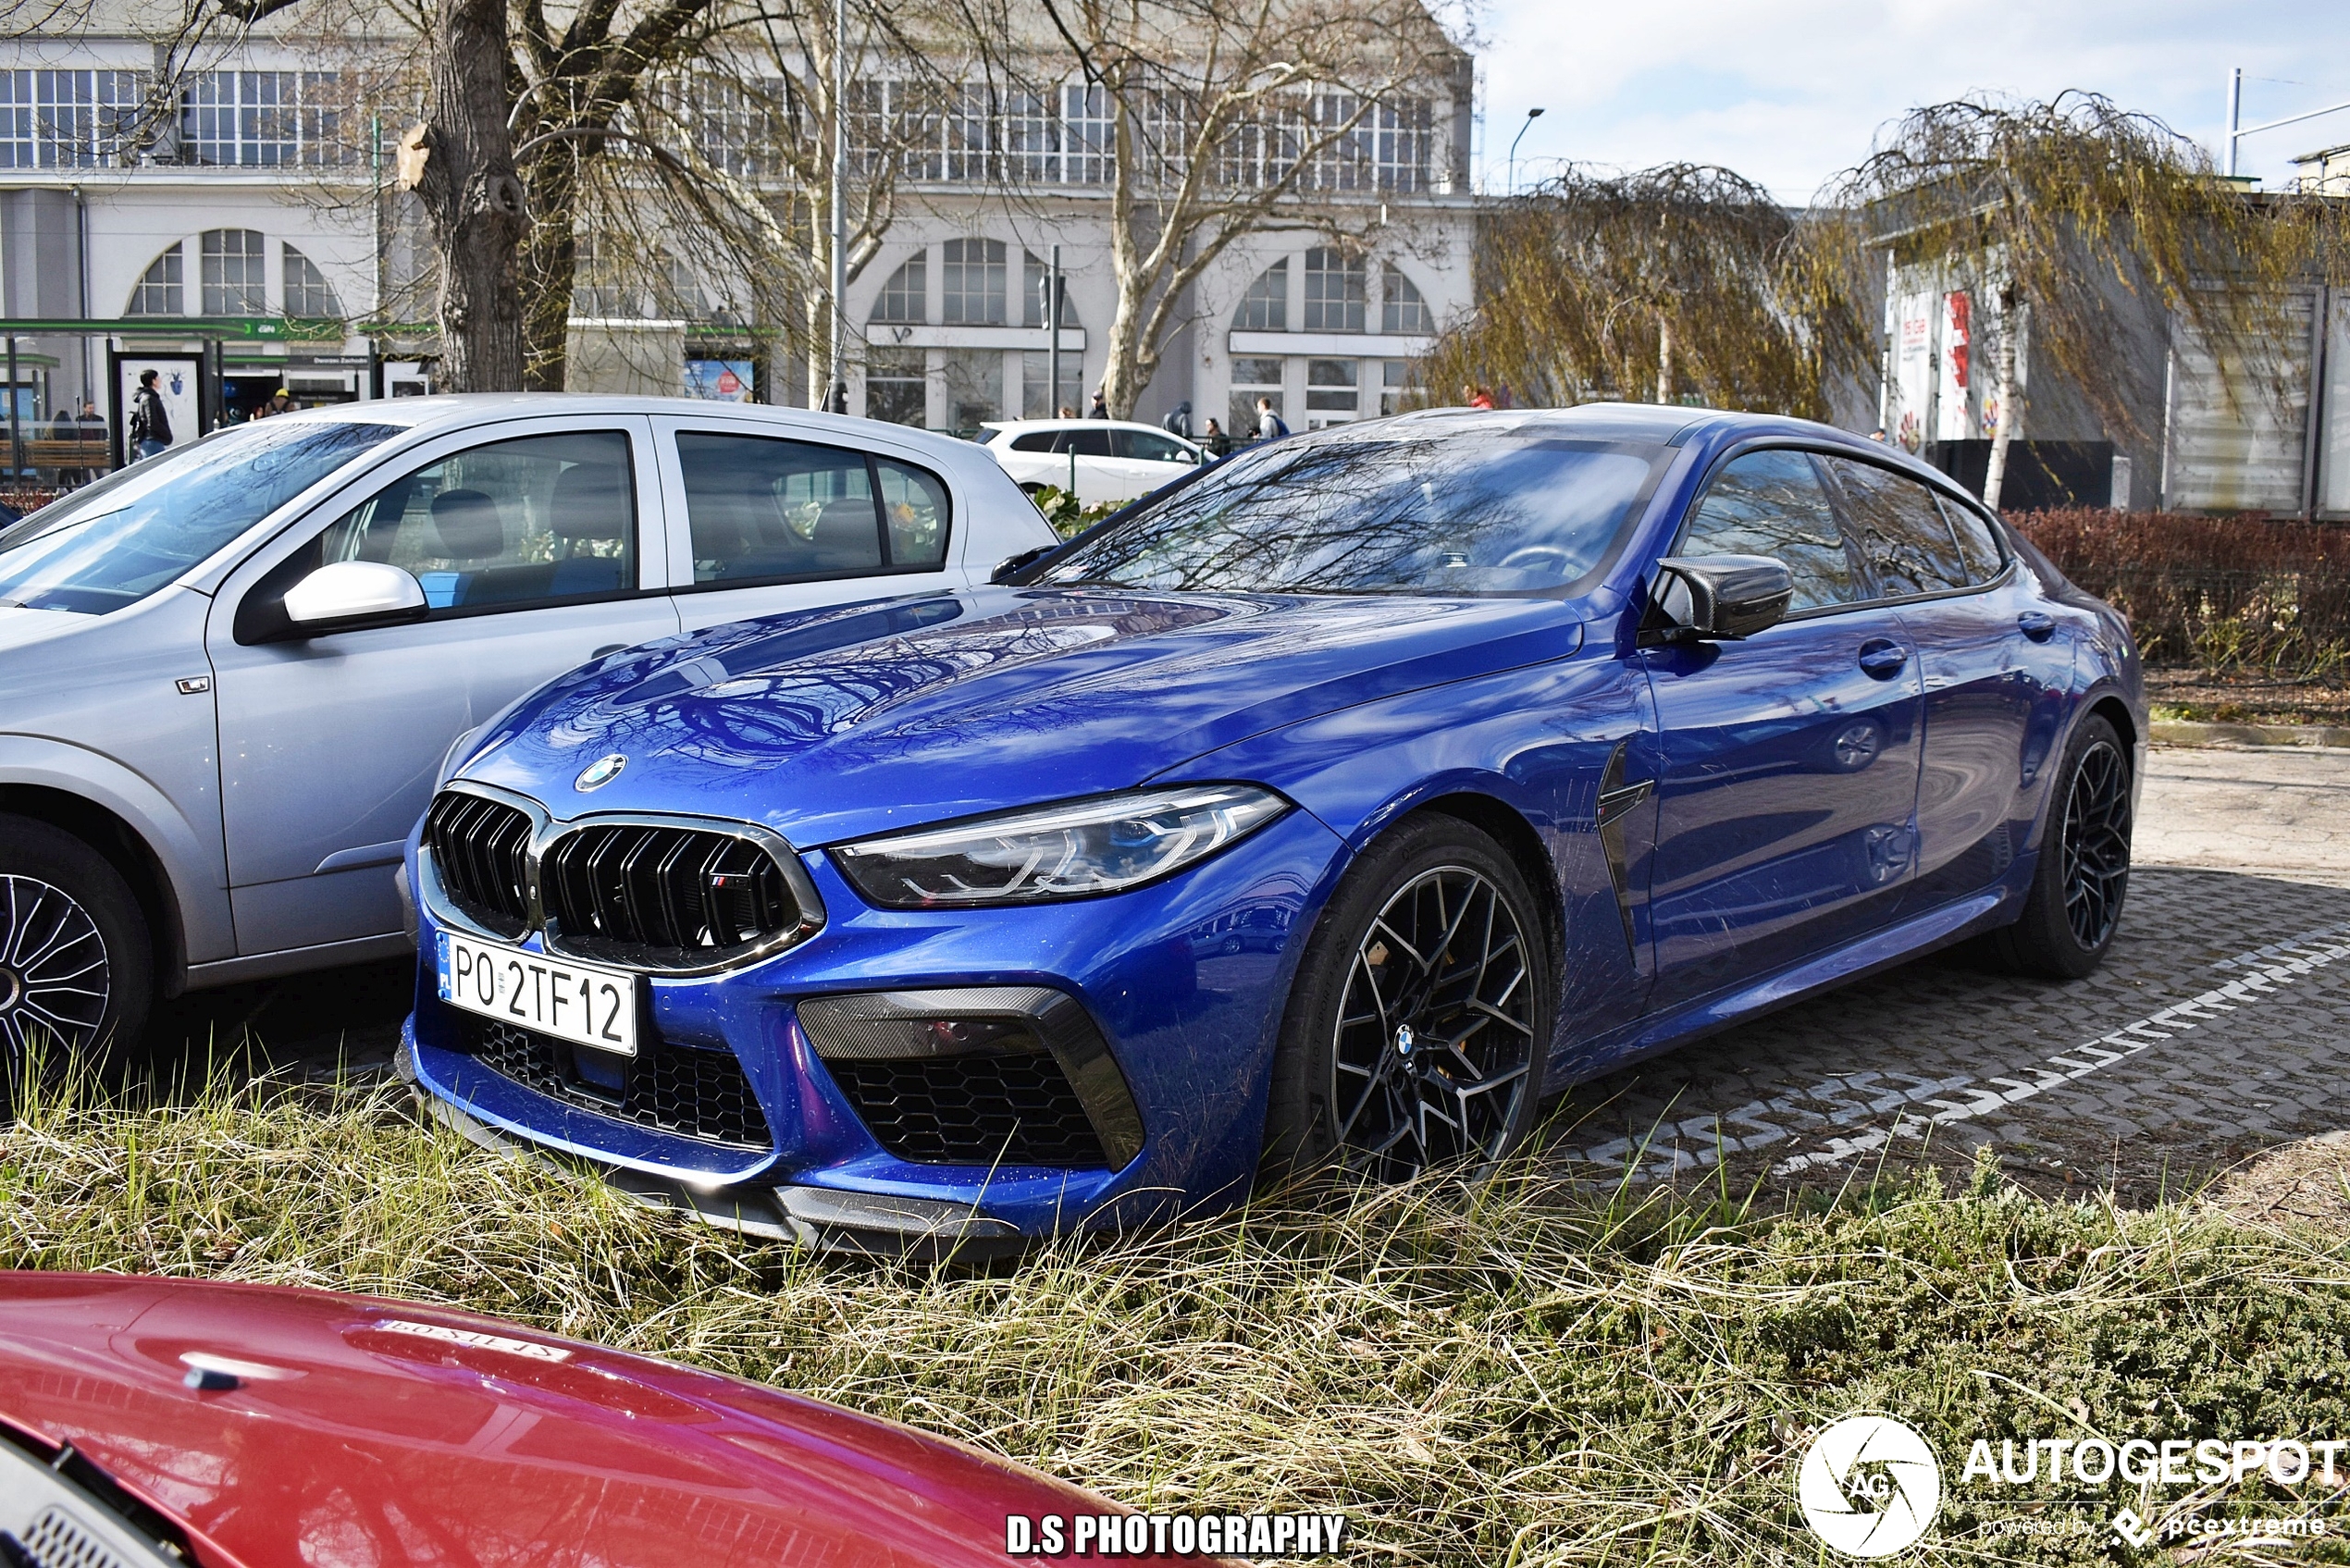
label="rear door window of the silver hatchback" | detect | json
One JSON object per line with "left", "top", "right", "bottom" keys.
{"left": 677, "top": 433, "right": 882, "bottom": 583}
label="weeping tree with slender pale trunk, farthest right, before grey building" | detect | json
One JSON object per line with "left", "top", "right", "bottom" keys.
{"left": 1831, "top": 92, "right": 2317, "bottom": 505}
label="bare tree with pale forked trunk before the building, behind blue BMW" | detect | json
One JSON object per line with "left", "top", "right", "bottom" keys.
{"left": 1015, "top": 0, "right": 1459, "bottom": 418}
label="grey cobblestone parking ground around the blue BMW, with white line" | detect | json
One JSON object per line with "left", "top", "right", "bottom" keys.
{"left": 151, "top": 747, "right": 2350, "bottom": 1202}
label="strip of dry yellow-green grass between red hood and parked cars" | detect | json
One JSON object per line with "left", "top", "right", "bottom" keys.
{"left": 0, "top": 1084, "right": 2350, "bottom": 1565}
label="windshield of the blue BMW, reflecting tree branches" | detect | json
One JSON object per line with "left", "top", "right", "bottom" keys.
{"left": 1036, "top": 433, "right": 1666, "bottom": 595}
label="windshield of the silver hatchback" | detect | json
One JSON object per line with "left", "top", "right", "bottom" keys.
{"left": 0, "top": 421, "right": 400, "bottom": 616}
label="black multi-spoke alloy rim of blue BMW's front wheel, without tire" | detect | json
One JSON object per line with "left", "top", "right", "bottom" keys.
{"left": 1330, "top": 865, "right": 1537, "bottom": 1182}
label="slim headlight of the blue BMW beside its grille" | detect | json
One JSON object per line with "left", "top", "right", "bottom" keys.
{"left": 832, "top": 785, "right": 1290, "bottom": 909}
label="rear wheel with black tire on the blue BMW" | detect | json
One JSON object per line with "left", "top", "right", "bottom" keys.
{"left": 1990, "top": 712, "right": 2132, "bottom": 981}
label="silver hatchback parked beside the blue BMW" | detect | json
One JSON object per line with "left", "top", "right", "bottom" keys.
{"left": 0, "top": 395, "right": 1055, "bottom": 1058}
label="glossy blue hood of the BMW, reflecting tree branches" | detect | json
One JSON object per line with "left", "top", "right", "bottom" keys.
{"left": 461, "top": 587, "right": 1581, "bottom": 848}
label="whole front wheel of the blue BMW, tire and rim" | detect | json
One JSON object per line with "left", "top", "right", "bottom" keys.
{"left": 1265, "top": 813, "right": 1558, "bottom": 1182}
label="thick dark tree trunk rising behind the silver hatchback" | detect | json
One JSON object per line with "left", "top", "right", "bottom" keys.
{"left": 416, "top": 0, "right": 529, "bottom": 392}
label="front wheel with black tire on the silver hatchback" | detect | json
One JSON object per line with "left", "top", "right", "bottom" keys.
{"left": 0, "top": 816, "right": 155, "bottom": 1081}
